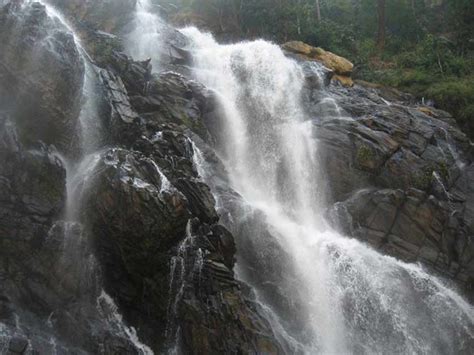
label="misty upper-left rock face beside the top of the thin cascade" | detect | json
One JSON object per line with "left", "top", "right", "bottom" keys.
{"left": 0, "top": 3, "right": 84, "bottom": 152}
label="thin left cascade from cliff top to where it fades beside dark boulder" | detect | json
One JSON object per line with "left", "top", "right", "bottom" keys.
{"left": 38, "top": 1, "right": 101, "bottom": 293}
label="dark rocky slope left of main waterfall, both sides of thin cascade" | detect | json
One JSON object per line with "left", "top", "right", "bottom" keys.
{"left": 0, "top": 3, "right": 280, "bottom": 353}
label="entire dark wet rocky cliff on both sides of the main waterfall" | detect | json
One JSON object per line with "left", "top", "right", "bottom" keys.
{"left": 0, "top": 0, "right": 474, "bottom": 354}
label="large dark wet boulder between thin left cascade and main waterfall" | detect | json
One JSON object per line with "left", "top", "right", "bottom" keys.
{"left": 85, "top": 143, "right": 280, "bottom": 354}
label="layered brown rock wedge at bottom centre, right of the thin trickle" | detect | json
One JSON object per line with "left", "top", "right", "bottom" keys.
{"left": 170, "top": 220, "right": 282, "bottom": 354}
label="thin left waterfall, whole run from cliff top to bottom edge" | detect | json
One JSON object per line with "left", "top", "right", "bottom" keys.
{"left": 35, "top": 1, "right": 153, "bottom": 355}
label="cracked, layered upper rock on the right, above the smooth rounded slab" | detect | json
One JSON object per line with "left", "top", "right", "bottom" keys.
{"left": 318, "top": 81, "right": 469, "bottom": 200}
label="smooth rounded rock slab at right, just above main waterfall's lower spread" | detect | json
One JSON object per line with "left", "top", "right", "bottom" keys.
{"left": 336, "top": 190, "right": 474, "bottom": 291}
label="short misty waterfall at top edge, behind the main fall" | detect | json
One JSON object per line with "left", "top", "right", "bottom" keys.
{"left": 125, "top": 0, "right": 162, "bottom": 70}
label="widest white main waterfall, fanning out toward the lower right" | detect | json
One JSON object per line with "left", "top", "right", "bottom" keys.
{"left": 182, "top": 28, "right": 474, "bottom": 354}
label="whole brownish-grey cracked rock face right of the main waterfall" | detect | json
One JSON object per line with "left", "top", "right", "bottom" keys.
{"left": 309, "top": 79, "right": 474, "bottom": 297}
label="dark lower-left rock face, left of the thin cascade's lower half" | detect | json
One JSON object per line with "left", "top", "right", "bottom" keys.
{"left": 0, "top": 114, "right": 144, "bottom": 354}
